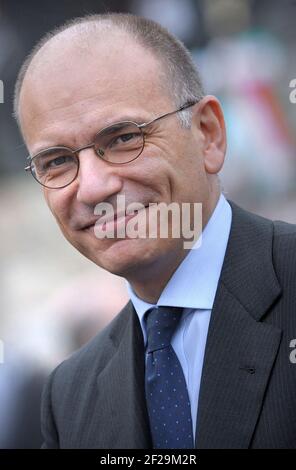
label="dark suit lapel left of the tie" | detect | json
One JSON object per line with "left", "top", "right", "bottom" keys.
{"left": 97, "top": 302, "right": 151, "bottom": 449}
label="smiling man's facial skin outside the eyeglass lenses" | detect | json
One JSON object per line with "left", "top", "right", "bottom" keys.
{"left": 20, "top": 34, "right": 222, "bottom": 279}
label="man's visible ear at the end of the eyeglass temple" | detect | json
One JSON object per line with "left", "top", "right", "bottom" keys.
{"left": 193, "top": 95, "right": 226, "bottom": 174}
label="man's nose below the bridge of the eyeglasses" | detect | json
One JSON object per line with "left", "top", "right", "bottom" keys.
{"left": 76, "top": 148, "right": 123, "bottom": 207}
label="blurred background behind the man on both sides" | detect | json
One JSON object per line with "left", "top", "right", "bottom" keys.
{"left": 0, "top": 0, "right": 296, "bottom": 448}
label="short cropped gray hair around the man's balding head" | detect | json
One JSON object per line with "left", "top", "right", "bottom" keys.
{"left": 14, "top": 13, "right": 204, "bottom": 127}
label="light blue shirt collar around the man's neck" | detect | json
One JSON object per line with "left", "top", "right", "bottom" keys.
{"left": 128, "top": 194, "right": 232, "bottom": 324}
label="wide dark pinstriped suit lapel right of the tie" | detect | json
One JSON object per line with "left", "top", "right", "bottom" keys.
{"left": 196, "top": 204, "right": 281, "bottom": 448}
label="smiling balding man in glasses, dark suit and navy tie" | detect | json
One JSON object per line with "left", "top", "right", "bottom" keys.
{"left": 15, "top": 14, "right": 296, "bottom": 449}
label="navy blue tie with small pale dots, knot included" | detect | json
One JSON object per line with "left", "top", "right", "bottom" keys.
{"left": 145, "top": 307, "right": 193, "bottom": 449}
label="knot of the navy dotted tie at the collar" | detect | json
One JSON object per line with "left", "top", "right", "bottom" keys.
{"left": 146, "top": 307, "right": 183, "bottom": 353}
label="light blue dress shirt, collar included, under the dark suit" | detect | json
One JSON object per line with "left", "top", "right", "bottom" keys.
{"left": 128, "top": 194, "right": 232, "bottom": 436}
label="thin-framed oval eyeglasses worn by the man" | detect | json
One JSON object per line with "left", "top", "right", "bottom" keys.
{"left": 25, "top": 101, "right": 197, "bottom": 189}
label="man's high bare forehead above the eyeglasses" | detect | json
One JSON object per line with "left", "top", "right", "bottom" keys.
{"left": 20, "top": 33, "right": 168, "bottom": 145}
